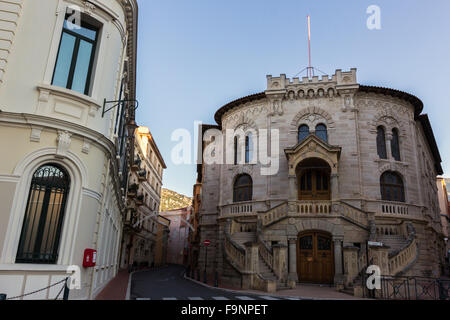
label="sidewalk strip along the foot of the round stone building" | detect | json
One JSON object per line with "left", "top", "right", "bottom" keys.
{"left": 186, "top": 273, "right": 362, "bottom": 300}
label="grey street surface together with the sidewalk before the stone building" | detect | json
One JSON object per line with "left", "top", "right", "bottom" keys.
{"left": 129, "top": 265, "right": 358, "bottom": 300}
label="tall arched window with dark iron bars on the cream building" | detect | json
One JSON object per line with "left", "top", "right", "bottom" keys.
{"left": 16, "top": 164, "right": 70, "bottom": 264}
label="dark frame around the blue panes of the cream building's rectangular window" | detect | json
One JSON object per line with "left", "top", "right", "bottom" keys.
{"left": 51, "top": 14, "right": 101, "bottom": 96}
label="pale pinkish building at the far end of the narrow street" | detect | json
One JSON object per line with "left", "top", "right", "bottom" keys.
{"left": 160, "top": 207, "right": 192, "bottom": 265}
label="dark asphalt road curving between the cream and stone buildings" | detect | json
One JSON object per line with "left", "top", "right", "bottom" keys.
{"left": 130, "top": 265, "right": 300, "bottom": 300}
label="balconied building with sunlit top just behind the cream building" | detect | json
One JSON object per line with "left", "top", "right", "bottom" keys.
{"left": 121, "top": 127, "right": 166, "bottom": 269}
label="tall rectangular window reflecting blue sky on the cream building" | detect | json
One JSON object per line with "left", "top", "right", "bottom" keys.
{"left": 52, "top": 16, "right": 99, "bottom": 95}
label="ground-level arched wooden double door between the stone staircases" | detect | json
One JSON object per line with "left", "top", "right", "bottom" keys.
{"left": 297, "top": 231, "right": 334, "bottom": 284}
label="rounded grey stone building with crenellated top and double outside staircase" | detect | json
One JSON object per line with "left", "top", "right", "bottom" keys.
{"left": 198, "top": 69, "right": 444, "bottom": 291}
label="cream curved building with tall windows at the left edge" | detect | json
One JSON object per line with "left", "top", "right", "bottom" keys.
{"left": 0, "top": 0, "right": 138, "bottom": 299}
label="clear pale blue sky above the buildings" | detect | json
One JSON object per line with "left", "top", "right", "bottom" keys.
{"left": 137, "top": 0, "right": 450, "bottom": 196}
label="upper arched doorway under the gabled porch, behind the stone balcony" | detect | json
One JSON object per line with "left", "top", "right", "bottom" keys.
{"left": 295, "top": 158, "right": 331, "bottom": 200}
